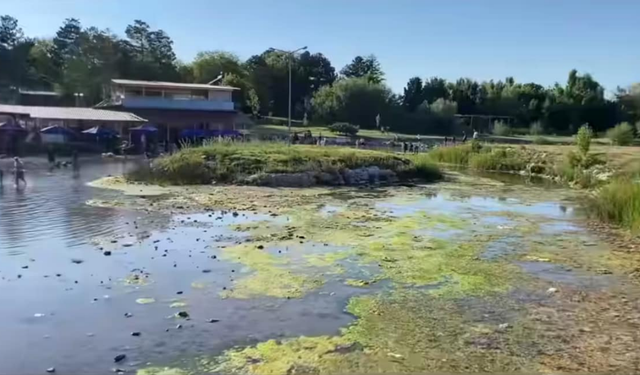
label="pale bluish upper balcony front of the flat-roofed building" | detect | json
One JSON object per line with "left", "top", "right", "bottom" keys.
{"left": 120, "top": 97, "right": 235, "bottom": 111}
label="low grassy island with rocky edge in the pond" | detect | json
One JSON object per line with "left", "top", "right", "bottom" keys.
{"left": 127, "top": 143, "right": 441, "bottom": 185}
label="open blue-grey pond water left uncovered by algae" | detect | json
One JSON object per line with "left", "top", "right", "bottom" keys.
{"left": 0, "top": 161, "right": 624, "bottom": 374}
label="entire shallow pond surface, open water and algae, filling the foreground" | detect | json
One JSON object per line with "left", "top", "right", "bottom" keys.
{"left": 0, "top": 163, "right": 639, "bottom": 374}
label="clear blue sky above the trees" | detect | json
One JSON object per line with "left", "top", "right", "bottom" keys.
{"left": 5, "top": 0, "right": 640, "bottom": 92}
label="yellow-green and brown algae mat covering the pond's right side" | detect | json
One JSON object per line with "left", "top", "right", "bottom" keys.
{"left": 114, "top": 183, "right": 640, "bottom": 375}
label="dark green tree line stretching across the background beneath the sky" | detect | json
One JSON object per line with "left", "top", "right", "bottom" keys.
{"left": 0, "top": 15, "right": 640, "bottom": 134}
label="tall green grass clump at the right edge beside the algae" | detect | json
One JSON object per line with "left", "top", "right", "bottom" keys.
{"left": 587, "top": 178, "right": 640, "bottom": 232}
